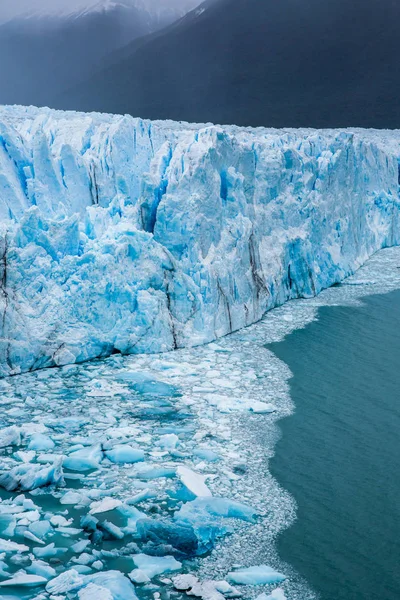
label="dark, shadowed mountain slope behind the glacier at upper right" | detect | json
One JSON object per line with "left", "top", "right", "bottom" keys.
{"left": 60, "top": 0, "right": 400, "bottom": 127}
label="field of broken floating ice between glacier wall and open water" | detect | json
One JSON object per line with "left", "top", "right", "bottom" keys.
{"left": 0, "top": 248, "right": 400, "bottom": 600}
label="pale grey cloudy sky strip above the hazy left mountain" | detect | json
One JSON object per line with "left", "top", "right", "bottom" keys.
{"left": 0, "top": 0, "right": 201, "bottom": 22}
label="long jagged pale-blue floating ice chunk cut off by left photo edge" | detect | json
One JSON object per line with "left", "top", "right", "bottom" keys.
{"left": 0, "top": 459, "right": 64, "bottom": 492}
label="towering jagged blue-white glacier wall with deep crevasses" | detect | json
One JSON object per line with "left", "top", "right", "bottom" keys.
{"left": 0, "top": 107, "right": 400, "bottom": 376}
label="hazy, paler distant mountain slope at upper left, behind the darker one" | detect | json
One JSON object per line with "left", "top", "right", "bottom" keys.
{"left": 0, "top": 0, "right": 200, "bottom": 105}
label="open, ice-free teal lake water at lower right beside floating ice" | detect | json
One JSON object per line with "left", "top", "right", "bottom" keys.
{"left": 268, "top": 291, "right": 400, "bottom": 600}
